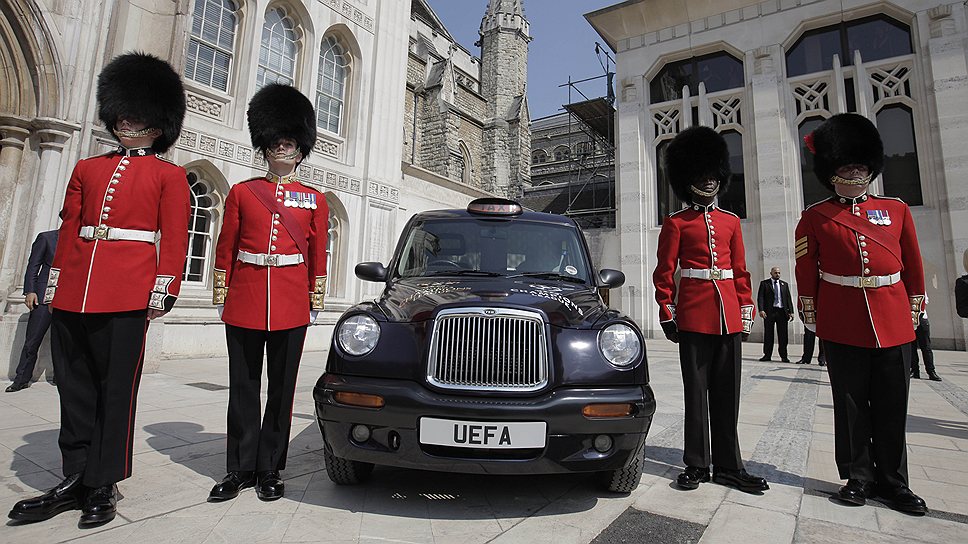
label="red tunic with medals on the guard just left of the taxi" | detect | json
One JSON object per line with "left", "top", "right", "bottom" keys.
{"left": 214, "top": 176, "right": 329, "bottom": 331}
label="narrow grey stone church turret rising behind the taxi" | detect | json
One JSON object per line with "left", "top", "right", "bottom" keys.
{"left": 478, "top": 0, "right": 531, "bottom": 198}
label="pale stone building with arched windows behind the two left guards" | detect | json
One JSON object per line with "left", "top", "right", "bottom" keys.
{"left": 0, "top": 0, "right": 530, "bottom": 372}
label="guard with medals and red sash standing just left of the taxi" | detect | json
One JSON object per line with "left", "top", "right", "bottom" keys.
{"left": 209, "top": 84, "right": 329, "bottom": 501}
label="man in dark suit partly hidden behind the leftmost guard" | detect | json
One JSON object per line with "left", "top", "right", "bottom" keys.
{"left": 7, "top": 230, "right": 57, "bottom": 393}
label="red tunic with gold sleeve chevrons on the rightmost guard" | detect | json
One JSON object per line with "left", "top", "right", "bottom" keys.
{"left": 796, "top": 195, "right": 925, "bottom": 348}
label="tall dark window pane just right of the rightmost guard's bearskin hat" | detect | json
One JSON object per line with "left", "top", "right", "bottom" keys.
{"left": 877, "top": 104, "right": 924, "bottom": 206}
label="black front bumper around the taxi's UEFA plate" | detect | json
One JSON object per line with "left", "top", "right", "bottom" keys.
{"left": 313, "top": 374, "right": 655, "bottom": 474}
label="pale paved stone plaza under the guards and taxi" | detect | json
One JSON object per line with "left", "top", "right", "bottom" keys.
{"left": 0, "top": 340, "right": 968, "bottom": 544}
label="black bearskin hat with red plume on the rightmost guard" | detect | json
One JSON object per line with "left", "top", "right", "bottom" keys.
{"left": 804, "top": 113, "right": 884, "bottom": 191}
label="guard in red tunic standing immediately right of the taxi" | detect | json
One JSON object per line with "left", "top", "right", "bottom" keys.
{"left": 652, "top": 127, "right": 769, "bottom": 492}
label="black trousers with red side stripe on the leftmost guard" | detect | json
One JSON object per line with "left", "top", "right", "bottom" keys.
{"left": 51, "top": 310, "right": 148, "bottom": 487}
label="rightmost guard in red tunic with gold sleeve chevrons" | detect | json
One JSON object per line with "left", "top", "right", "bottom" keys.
{"left": 796, "top": 113, "right": 927, "bottom": 514}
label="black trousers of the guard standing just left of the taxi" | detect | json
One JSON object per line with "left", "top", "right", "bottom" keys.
{"left": 225, "top": 325, "right": 307, "bottom": 472}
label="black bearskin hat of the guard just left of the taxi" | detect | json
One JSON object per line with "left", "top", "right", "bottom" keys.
{"left": 248, "top": 83, "right": 316, "bottom": 158}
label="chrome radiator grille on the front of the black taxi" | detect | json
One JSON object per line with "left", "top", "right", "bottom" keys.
{"left": 427, "top": 308, "right": 548, "bottom": 391}
